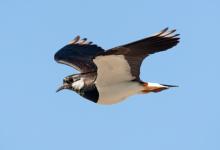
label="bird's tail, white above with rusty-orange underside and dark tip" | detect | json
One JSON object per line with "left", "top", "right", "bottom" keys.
{"left": 142, "top": 82, "right": 178, "bottom": 93}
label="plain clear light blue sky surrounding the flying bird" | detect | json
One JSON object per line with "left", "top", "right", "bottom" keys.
{"left": 0, "top": 0, "right": 220, "bottom": 150}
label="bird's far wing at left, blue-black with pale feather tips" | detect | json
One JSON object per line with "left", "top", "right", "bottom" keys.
{"left": 54, "top": 36, "right": 104, "bottom": 73}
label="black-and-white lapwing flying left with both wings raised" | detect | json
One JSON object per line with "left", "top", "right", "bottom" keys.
{"left": 54, "top": 28, "right": 180, "bottom": 104}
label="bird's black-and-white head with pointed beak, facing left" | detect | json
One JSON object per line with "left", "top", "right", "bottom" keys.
{"left": 56, "top": 75, "right": 84, "bottom": 92}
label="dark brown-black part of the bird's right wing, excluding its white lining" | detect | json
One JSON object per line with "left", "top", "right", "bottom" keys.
{"left": 99, "top": 28, "right": 180, "bottom": 79}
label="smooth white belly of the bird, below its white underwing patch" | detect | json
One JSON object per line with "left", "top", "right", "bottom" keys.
{"left": 98, "top": 81, "right": 143, "bottom": 104}
